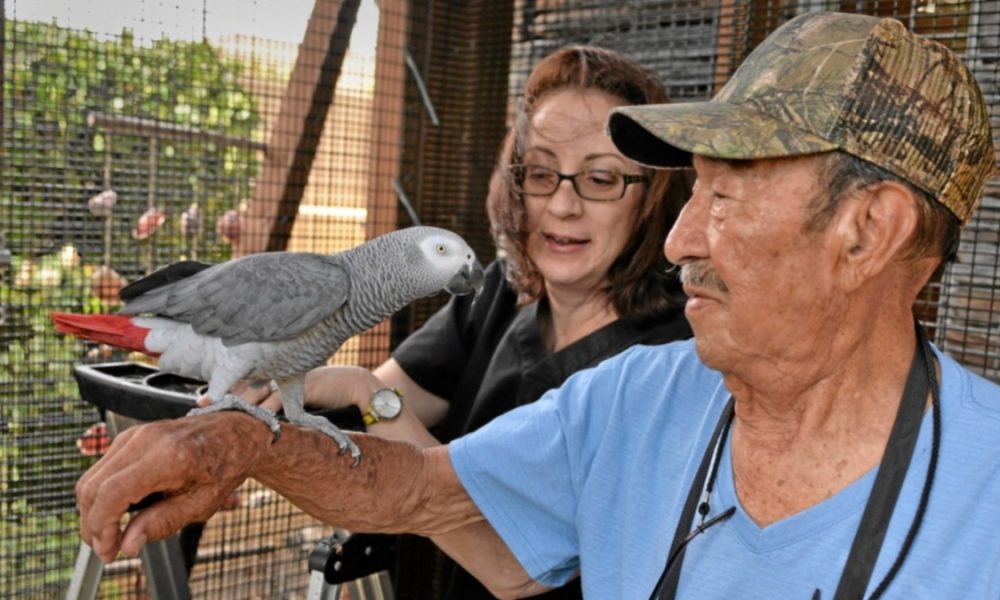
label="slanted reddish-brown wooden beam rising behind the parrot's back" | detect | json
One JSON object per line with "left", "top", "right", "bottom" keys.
{"left": 233, "top": 0, "right": 361, "bottom": 256}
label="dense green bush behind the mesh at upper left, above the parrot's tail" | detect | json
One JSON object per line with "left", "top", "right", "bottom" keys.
{"left": 0, "top": 21, "right": 260, "bottom": 260}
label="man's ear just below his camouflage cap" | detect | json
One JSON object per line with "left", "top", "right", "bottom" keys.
{"left": 837, "top": 181, "right": 919, "bottom": 289}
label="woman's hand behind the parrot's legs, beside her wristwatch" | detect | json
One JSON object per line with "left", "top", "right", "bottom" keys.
{"left": 198, "top": 366, "right": 386, "bottom": 412}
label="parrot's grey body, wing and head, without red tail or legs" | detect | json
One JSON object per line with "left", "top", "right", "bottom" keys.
{"left": 121, "top": 227, "right": 482, "bottom": 346}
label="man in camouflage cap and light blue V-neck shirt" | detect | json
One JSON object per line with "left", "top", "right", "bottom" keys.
{"left": 79, "top": 14, "right": 1000, "bottom": 599}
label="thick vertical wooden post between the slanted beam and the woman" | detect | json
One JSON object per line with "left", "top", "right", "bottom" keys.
{"left": 361, "top": 0, "right": 514, "bottom": 364}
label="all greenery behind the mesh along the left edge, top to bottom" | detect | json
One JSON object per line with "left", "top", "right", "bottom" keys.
{"left": 0, "top": 20, "right": 261, "bottom": 598}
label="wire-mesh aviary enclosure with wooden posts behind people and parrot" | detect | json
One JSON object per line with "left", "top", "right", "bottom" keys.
{"left": 0, "top": 0, "right": 1000, "bottom": 599}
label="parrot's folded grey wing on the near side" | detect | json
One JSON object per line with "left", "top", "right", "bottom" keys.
{"left": 126, "top": 252, "right": 351, "bottom": 346}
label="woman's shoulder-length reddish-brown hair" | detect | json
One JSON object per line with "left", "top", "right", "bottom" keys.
{"left": 487, "top": 46, "right": 693, "bottom": 322}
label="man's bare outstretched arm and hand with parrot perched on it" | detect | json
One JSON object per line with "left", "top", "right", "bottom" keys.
{"left": 77, "top": 412, "right": 548, "bottom": 591}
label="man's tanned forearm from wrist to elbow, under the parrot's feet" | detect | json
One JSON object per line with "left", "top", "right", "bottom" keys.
{"left": 251, "top": 418, "right": 483, "bottom": 535}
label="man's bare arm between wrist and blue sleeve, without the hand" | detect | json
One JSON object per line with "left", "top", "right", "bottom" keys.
{"left": 252, "top": 418, "right": 547, "bottom": 598}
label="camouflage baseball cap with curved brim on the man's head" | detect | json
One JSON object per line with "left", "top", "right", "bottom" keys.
{"left": 608, "top": 13, "right": 996, "bottom": 223}
